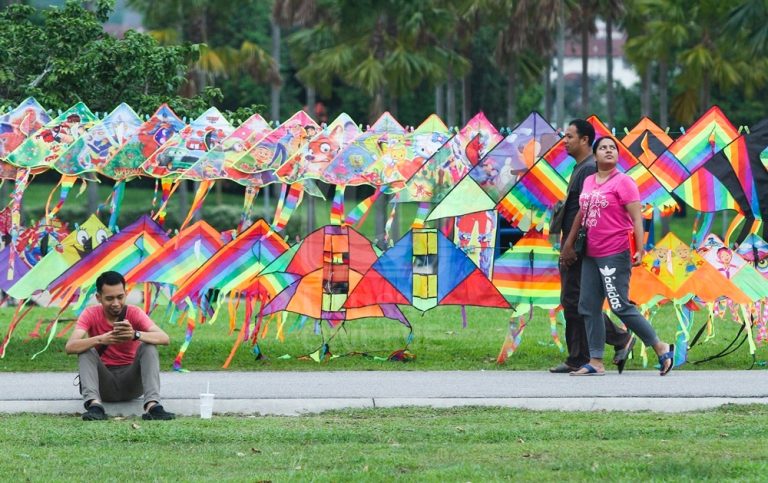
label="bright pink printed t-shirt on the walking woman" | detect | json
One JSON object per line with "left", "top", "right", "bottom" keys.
{"left": 579, "top": 172, "right": 640, "bottom": 257}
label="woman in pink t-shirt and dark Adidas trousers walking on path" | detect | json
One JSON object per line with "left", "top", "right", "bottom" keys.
{"left": 562, "top": 137, "right": 674, "bottom": 376}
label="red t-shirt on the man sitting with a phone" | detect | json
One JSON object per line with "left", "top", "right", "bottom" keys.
{"left": 75, "top": 305, "right": 154, "bottom": 366}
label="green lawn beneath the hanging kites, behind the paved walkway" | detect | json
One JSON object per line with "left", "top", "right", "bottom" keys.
{"left": 0, "top": 307, "right": 768, "bottom": 371}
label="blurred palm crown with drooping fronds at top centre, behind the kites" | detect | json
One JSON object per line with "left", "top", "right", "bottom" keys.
{"left": 289, "top": 0, "right": 469, "bottom": 121}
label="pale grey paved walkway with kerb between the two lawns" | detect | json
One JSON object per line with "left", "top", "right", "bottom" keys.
{"left": 0, "top": 370, "right": 768, "bottom": 415}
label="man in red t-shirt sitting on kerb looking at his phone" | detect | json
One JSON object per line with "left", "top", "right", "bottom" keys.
{"left": 65, "top": 272, "right": 175, "bottom": 421}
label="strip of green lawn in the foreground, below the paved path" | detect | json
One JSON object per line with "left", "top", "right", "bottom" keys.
{"left": 0, "top": 406, "right": 768, "bottom": 481}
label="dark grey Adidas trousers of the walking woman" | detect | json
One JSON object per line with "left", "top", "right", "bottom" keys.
{"left": 579, "top": 250, "right": 659, "bottom": 359}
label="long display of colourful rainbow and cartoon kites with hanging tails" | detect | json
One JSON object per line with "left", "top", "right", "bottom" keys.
{"left": 0, "top": 98, "right": 768, "bottom": 368}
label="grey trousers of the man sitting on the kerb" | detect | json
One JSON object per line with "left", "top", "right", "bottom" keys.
{"left": 78, "top": 343, "right": 160, "bottom": 405}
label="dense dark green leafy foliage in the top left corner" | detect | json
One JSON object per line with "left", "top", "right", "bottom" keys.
{"left": 0, "top": 0, "right": 210, "bottom": 117}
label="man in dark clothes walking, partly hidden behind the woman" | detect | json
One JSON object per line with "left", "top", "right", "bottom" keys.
{"left": 549, "top": 119, "right": 635, "bottom": 373}
